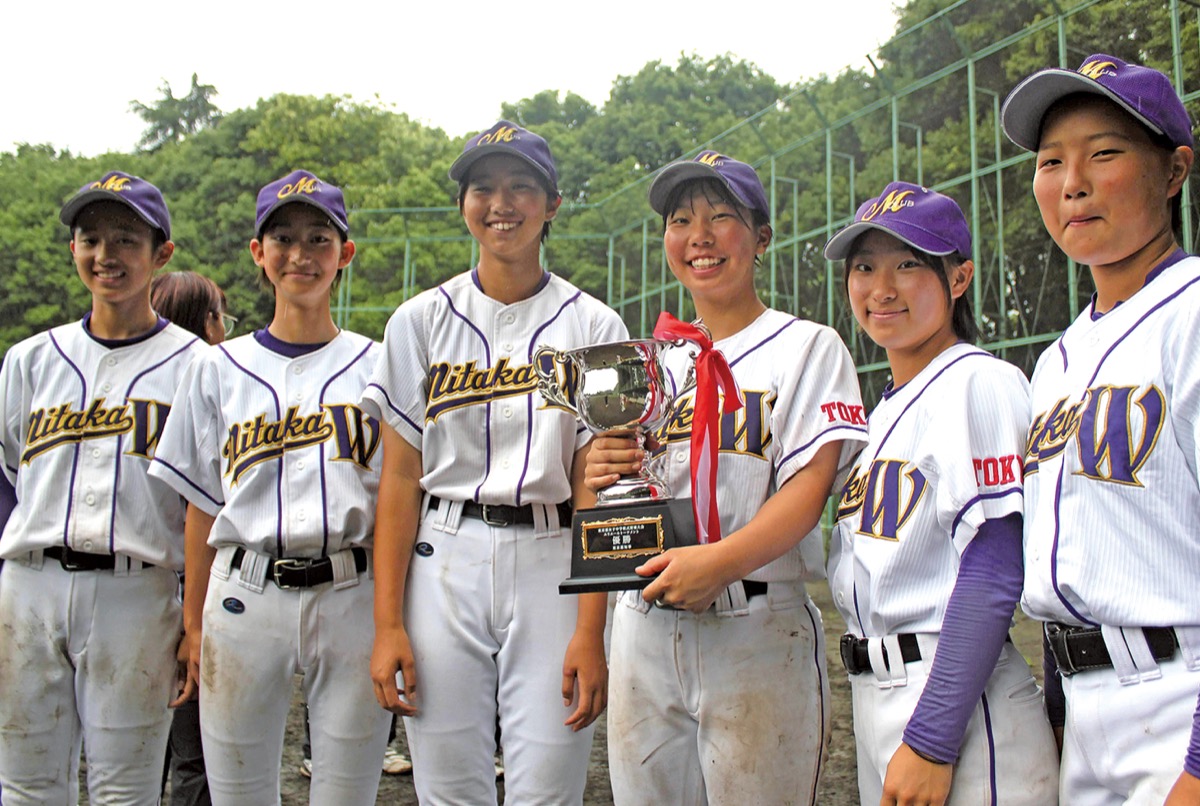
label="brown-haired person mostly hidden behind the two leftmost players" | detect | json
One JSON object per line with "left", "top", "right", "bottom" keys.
{"left": 150, "top": 271, "right": 231, "bottom": 806}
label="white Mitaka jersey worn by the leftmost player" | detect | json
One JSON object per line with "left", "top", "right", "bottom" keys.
{"left": 0, "top": 319, "right": 206, "bottom": 570}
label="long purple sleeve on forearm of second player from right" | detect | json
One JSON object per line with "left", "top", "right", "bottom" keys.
{"left": 904, "top": 513, "right": 1025, "bottom": 764}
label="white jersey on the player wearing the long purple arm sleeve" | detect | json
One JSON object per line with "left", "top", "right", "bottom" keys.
{"left": 829, "top": 343, "right": 1030, "bottom": 637}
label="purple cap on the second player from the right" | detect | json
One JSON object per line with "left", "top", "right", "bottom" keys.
{"left": 824, "top": 182, "right": 971, "bottom": 260}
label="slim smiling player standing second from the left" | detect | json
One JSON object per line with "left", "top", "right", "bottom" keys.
{"left": 144, "top": 170, "right": 388, "bottom": 806}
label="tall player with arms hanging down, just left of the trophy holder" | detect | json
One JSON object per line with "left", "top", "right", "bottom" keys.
{"left": 364, "top": 121, "right": 628, "bottom": 805}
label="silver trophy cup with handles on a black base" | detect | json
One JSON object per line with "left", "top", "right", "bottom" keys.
{"left": 533, "top": 338, "right": 696, "bottom": 594}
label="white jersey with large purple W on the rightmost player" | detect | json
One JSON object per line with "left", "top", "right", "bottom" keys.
{"left": 1022, "top": 257, "right": 1200, "bottom": 627}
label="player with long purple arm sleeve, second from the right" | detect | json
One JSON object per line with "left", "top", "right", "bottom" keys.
{"left": 824, "top": 182, "right": 1058, "bottom": 806}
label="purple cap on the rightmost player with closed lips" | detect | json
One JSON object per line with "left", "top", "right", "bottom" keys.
{"left": 1000, "top": 53, "right": 1194, "bottom": 151}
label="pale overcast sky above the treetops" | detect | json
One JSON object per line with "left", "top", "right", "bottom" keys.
{"left": 0, "top": 0, "right": 895, "bottom": 156}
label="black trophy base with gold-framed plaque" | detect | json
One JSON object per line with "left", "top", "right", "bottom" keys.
{"left": 558, "top": 498, "right": 696, "bottom": 594}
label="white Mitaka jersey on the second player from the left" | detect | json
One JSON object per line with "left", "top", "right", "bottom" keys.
{"left": 151, "top": 330, "right": 383, "bottom": 558}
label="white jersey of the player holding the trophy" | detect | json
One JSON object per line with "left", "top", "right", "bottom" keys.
{"left": 638, "top": 311, "right": 866, "bottom": 580}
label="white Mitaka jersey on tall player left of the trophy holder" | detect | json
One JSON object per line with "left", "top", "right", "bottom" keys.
{"left": 362, "top": 272, "right": 628, "bottom": 505}
